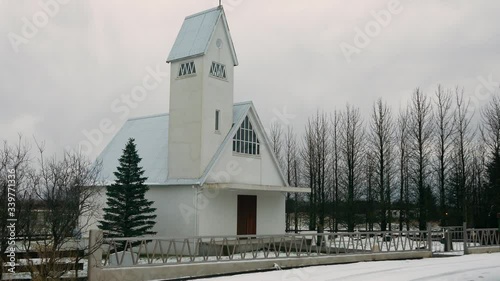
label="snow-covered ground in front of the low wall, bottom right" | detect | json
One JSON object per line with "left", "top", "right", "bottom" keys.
{"left": 193, "top": 253, "right": 500, "bottom": 281}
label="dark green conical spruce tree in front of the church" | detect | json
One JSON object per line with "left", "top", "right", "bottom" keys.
{"left": 99, "top": 139, "right": 156, "bottom": 237}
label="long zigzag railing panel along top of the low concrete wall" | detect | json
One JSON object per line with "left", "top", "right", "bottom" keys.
{"left": 97, "top": 231, "right": 430, "bottom": 267}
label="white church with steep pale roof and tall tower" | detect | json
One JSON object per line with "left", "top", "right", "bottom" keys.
{"left": 91, "top": 6, "right": 310, "bottom": 237}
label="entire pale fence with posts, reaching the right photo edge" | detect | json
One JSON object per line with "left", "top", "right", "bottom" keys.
{"left": 88, "top": 224, "right": 500, "bottom": 280}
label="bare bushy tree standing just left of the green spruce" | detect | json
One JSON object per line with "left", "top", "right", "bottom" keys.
{"left": 33, "top": 140, "right": 100, "bottom": 251}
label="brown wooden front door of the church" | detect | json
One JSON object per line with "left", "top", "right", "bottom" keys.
{"left": 237, "top": 195, "right": 257, "bottom": 235}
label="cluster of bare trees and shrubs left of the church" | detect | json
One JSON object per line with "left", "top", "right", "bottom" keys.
{"left": 0, "top": 137, "right": 100, "bottom": 280}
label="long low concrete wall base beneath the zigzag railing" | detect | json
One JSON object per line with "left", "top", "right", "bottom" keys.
{"left": 95, "top": 251, "right": 432, "bottom": 281}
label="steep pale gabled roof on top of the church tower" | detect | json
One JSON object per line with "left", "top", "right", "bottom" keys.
{"left": 167, "top": 6, "right": 238, "bottom": 65}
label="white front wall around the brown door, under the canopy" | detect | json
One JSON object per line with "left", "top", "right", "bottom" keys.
{"left": 198, "top": 189, "right": 285, "bottom": 236}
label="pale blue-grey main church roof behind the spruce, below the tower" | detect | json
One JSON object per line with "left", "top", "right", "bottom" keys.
{"left": 97, "top": 102, "right": 252, "bottom": 185}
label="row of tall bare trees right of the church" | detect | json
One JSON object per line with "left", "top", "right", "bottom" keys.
{"left": 270, "top": 86, "right": 500, "bottom": 231}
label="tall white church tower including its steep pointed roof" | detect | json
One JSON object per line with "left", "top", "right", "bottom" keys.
{"left": 167, "top": 6, "right": 238, "bottom": 180}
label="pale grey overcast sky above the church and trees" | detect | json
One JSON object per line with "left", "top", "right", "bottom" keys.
{"left": 0, "top": 0, "right": 500, "bottom": 156}
